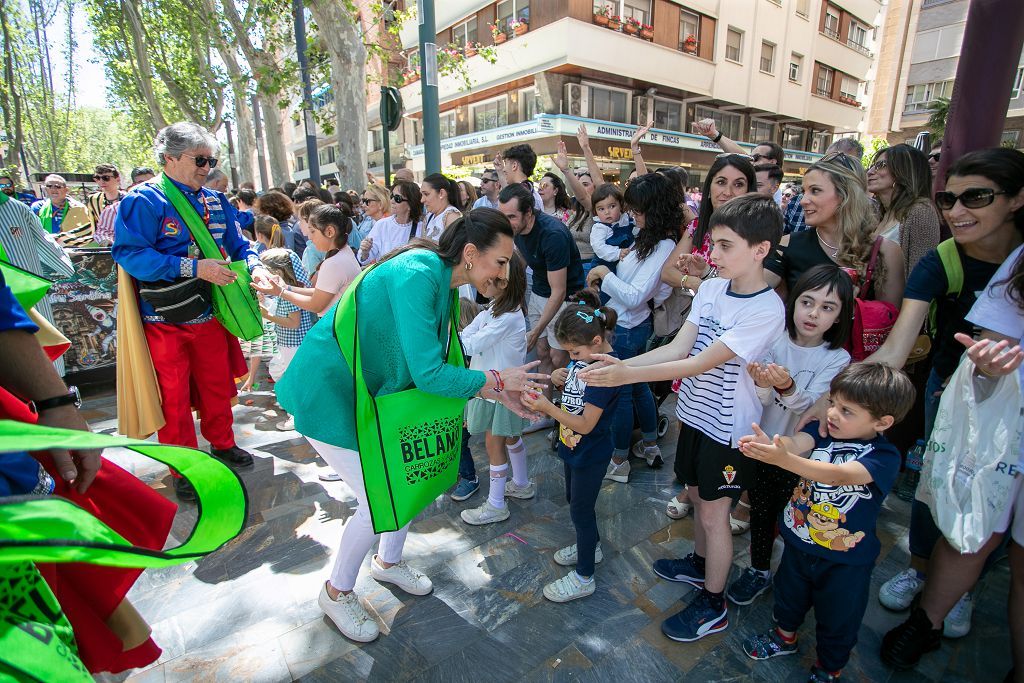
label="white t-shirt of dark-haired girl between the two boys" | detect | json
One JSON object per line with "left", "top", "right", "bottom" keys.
{"left": 755, "top": 333, "right": 850, "bottom": 436}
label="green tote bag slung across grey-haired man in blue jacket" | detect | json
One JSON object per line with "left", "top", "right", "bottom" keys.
{"left": 160, "top": 173, "right": 263, "bottom": 341}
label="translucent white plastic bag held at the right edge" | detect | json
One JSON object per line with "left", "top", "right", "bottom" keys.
{"left": 918, "top": 355, "right": 1022, "bottom": 553}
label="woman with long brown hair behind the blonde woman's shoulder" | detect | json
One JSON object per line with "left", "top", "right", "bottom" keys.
{"left": 867, "top": 144, "right": 939, "bottom": 272}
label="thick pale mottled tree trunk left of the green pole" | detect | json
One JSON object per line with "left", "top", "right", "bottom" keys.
{"left": 306, "top": 0, "right": 367, "bottom": 189}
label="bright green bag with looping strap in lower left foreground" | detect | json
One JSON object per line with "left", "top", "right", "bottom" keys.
{"left": 0, "top": 420, "right": 247, "bottom": 682}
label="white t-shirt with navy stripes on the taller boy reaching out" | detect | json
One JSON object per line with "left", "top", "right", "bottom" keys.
{"left": 676, "top": 278, "right": 785, "bottom": 447}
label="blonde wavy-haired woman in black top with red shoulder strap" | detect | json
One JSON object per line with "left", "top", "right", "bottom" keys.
{"left": 765, "top": 153, "right": 905, "bottom": 306}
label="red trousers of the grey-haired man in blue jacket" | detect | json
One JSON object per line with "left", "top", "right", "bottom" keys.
{"left": 142, "top": 319, "right": 245, "bottom": 449}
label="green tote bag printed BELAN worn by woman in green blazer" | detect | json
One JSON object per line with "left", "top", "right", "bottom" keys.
{"left": 334, "top": 268, "right": 467, "bottom": 533}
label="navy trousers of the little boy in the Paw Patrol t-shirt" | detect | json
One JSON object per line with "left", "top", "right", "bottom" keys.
{"left": 774, "top": 545, "right": 874, "bottom": 671}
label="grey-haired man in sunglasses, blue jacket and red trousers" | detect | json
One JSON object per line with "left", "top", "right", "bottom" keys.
{"left": 111, "top": 122, "right": 270, "bottom": 501}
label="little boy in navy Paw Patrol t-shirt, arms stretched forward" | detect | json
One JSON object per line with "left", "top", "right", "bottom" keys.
{"left": 739, "top": 362, "right": 914, "bottom": 683}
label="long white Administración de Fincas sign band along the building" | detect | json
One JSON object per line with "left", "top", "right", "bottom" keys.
{"left": 412, "top": 114, "right": 821, "bottom": 164}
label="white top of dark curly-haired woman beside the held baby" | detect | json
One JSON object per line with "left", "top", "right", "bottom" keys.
{"left": 595, "top": 237, "right": 676, "bottom": 330}
